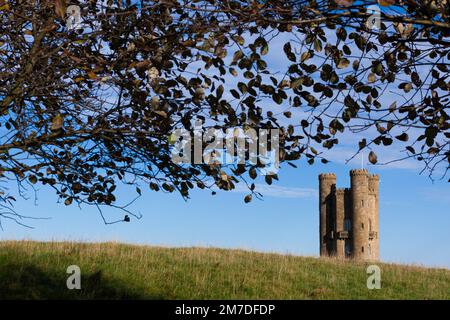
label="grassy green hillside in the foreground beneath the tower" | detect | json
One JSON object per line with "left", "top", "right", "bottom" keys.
{"left": 0, "top": 241, "right": 450, "bottom": 299}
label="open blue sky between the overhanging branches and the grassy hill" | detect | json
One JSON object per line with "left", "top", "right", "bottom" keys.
{"left": 0, "top": 1, "right": 450, "bottom": 268}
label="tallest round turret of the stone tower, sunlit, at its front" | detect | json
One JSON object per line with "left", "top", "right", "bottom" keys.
{"left": 350, "top": 169, "right": 370, "bottom": 260}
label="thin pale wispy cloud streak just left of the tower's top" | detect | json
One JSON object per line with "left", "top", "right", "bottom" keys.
{"left": 233, "top": 184, "right": 318, "bottom": 199}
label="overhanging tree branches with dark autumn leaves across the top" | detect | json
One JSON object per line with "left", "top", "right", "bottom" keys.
{"left": 0, "top": 0, "right": 450, "bottom": 222}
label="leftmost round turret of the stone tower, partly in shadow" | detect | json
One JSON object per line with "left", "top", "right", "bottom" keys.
{"left": 319, "top": 173, "right": 336, "bottom": 256}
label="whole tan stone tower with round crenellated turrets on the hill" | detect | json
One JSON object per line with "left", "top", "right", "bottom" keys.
{"left": 319, "top": 169, "right": 380, "bottom": 260}
